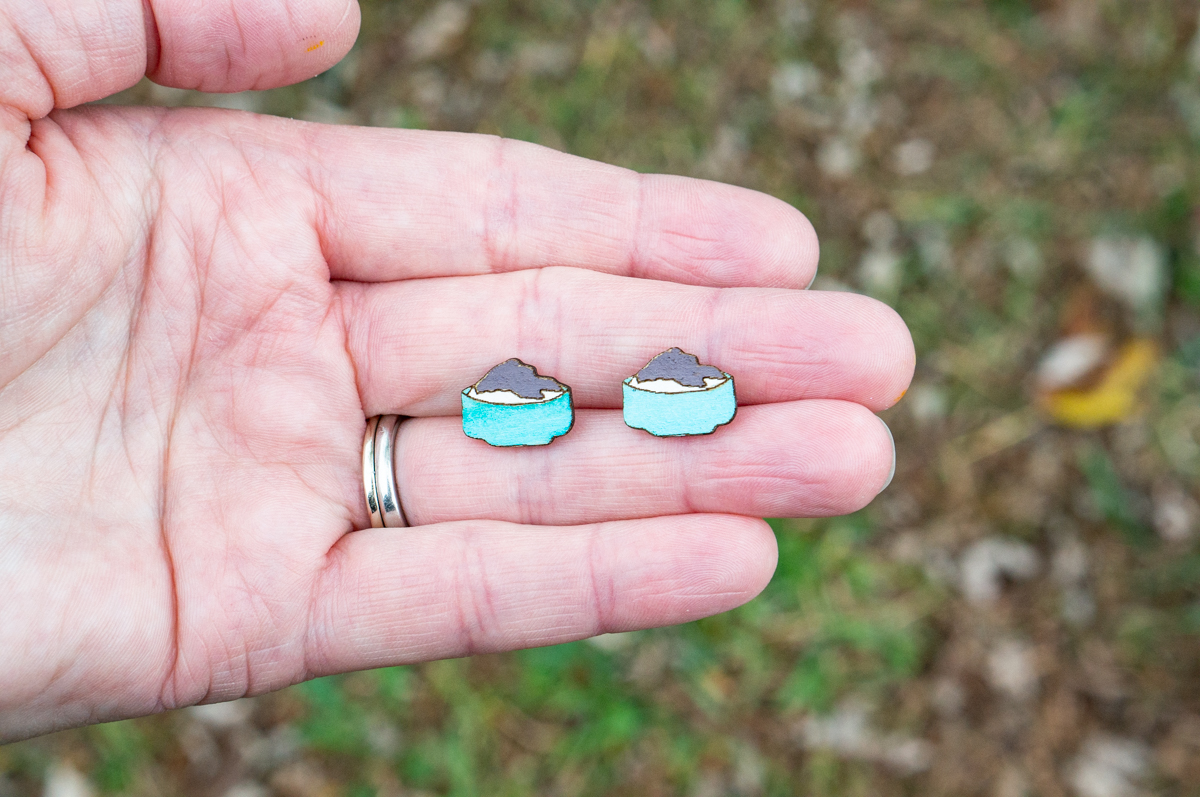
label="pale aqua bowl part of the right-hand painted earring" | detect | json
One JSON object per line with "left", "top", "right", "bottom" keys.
{"left": 622, "top": 373, "right": 738, "bottom": 437}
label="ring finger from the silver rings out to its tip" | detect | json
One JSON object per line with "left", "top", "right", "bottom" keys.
{"left": 396, "top": 400, "right": 894, "bottom": 526}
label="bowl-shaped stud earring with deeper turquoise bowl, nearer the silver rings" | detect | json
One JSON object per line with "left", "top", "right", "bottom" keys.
{"left": 462, "top": 358, "right": 575, "bottom": 447}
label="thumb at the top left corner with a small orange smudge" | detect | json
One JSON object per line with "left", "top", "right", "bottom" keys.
{"left": 0, "top": 0, "right": 360, "bottom": 119}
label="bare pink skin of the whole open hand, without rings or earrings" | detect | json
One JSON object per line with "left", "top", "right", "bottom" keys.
{"left": 0, "top": 0, "right": 913, "bottom": 739}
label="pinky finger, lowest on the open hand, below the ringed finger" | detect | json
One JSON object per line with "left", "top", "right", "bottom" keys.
{"left": 306, "top": 515, "right": 776, "bottom": 676}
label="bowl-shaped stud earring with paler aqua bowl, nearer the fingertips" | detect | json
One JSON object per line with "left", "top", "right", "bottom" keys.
{"left": 622, "top": 347, "right": 738, "bottom": 437}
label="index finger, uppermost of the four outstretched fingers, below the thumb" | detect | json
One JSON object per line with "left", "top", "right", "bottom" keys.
{"left": 304, "top": 126, "right": 818, "bottom": 288}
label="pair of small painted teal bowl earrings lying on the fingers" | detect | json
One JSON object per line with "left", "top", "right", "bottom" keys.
{"left": 462, "top": 348, "right": 738, "bottom": 447}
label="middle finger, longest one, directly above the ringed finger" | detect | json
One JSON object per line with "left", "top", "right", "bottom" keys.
{"left": 338, "top": 268, "right": 914, "bottom": 417}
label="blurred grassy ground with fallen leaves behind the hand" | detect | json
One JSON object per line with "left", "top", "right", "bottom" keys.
{"left": 0, "top": 0, "right": 1200, "bottom": 797}
